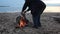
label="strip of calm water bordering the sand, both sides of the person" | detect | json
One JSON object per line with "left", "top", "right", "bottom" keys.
{"left": 0, "top": 6, "right": 60, "bottom": 13}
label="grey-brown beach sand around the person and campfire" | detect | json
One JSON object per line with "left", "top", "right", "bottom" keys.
{"left": 0, "top": 12, "right": 60, "bottom": 34}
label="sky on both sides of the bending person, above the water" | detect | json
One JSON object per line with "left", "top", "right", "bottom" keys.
{"left": 0, "top": 0, "right": 60, "bottom": 7}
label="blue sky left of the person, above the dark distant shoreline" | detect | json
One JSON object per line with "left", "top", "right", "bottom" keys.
{"left": 0, "top": 0, "right": 24, "bottom": 7}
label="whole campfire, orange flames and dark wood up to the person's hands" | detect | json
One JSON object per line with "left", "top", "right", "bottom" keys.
{"left": 16, "top": 13, "right": 29, "bottom": 28}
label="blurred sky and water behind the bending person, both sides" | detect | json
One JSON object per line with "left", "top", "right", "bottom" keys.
{"left": 0, "top": 0, "right": 60, "bottom": 13}
